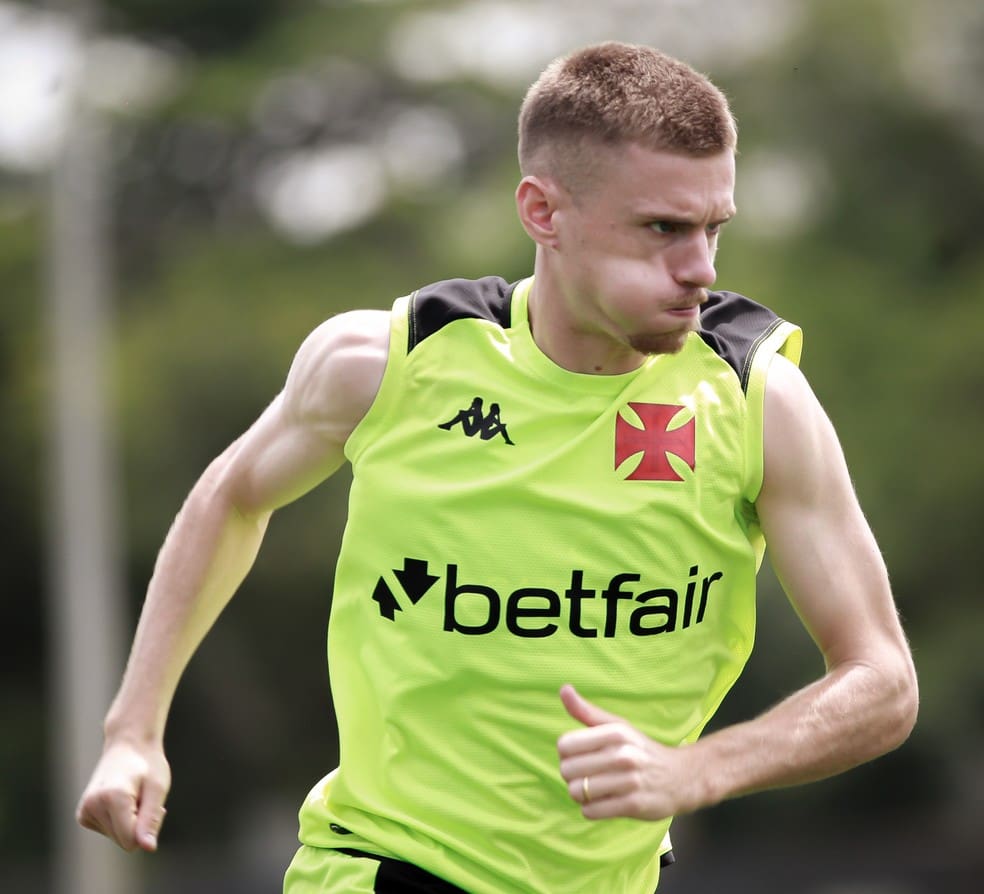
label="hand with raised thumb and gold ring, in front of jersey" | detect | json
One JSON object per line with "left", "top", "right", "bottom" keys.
{"left": 557, "top": 685, "right": 697, "bottom": 820}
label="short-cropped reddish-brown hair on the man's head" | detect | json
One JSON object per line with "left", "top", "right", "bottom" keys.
{"left": 519, "top": 42, "right": 738, "bottom": 189}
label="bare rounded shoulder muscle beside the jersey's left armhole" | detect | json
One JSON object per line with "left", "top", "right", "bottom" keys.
{"left": 283, "top": 310, "right": 390, "bottom": 442}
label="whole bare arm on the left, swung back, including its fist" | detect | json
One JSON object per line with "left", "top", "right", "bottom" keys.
{"left": 78, "top": 311, "right": 389, "bottom": 851}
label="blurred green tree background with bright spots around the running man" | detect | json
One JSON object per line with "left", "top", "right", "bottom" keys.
{"left": 0, "top": 0, "right": 984, "bottom": 894}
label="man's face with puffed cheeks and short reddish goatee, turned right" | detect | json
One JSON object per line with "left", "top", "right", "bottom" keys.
{"left": 552, "top": 144, "right": 735, "bottom": 357}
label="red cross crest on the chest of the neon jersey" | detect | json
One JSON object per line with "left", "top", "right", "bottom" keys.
{"left": 615, "top": 402, "right": 697, "bottom": 481}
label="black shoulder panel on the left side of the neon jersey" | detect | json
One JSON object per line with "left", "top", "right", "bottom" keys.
{"left": 407, "top": 276, "right": 516, "bottom": 354}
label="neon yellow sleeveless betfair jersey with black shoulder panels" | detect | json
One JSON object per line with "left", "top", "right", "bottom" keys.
{"left": 300, "top": 277, "right": 801, "bottom": 894}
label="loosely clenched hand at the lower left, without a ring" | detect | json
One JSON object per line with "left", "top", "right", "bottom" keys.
{"left": 76, "top": 743, "right": 171, "bottom": 852}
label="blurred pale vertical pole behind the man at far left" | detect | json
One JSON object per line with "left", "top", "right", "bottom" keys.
{"left": 48, "top": 8, "right": 139, "bottom": 894}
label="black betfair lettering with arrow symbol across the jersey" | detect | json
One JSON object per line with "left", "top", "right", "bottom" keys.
{"left": 372, "top": 558, "right": 724, "bottom": 639}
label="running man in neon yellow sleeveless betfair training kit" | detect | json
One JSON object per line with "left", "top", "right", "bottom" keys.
{"left": 79, "top": 44, "right": 917, "bottom": 894}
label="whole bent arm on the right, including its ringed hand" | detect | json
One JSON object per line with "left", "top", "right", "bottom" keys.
{"left": 559, "top": 357, "right": 917, "bottom": 819}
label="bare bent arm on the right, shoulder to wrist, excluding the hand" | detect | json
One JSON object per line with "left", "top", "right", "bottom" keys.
{"left": 680, "top": 357, "right": 917, "bottom": 802}
